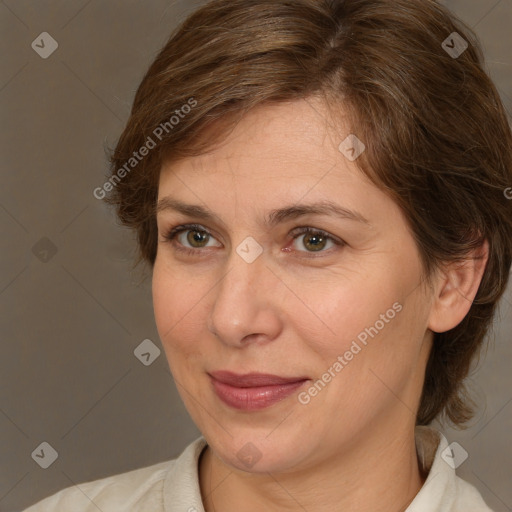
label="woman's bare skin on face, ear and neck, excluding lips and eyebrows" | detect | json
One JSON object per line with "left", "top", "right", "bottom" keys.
{"left": 153, "top": 99, "right": 485, "bottom": 512}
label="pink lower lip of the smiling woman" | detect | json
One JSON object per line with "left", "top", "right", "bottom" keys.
{"left": 212, "top": 378, "right": 307, "bottom": 411}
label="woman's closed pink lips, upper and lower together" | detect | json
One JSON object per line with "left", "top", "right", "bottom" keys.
{"left": 209, "top": 371, "right": 309, "bottom": 411}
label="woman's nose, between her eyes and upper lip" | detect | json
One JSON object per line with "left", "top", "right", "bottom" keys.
{"left": 208, "top": 248, "right": 283, "bottom": 348}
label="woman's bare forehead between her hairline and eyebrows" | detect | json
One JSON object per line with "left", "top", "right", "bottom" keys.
{"left": 157, "top": 101, "right": 404, "bottom": 244}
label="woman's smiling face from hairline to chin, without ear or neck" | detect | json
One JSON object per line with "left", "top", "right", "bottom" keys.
{"left": 153, "top": 101, "right": 432, "bottom": 472}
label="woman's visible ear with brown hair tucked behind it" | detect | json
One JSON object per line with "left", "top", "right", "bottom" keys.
{"left": 428, "top": 240, "right": 489, "bottom": 333}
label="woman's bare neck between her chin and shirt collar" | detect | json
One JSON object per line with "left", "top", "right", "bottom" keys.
{"left": 199, "top": 421, "right": 426, "bottom": 512}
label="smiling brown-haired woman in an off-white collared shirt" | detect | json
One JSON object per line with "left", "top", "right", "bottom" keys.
{"left": 28, "top": 0, "right": 512, "bottom": 512}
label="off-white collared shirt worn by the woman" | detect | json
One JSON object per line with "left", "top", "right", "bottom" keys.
{"left": 25, "top": 427, "right": 492, "bottom": 512}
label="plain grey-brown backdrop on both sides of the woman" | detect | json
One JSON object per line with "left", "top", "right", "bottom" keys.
{"left": 0, "top": 0, "right": 512, "bottom": 512}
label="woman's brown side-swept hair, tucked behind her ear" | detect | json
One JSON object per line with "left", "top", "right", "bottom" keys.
{"left": 105, "top": 0, "right": 512, "bottom": 425}
